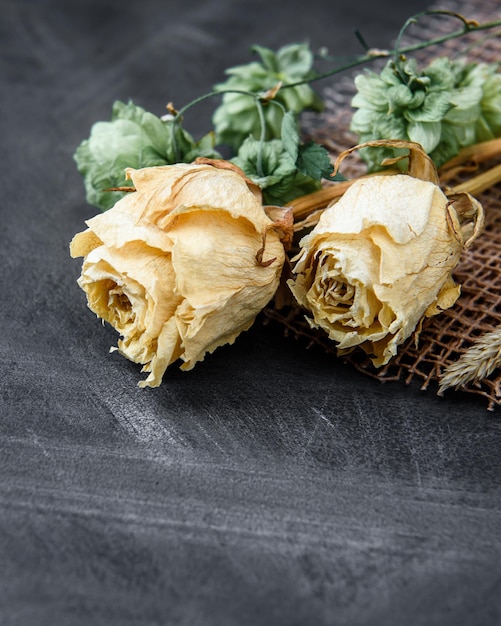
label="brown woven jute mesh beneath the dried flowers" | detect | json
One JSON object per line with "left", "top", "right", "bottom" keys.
{"left": 266, "top": 0, "right": 501, "bottom": 410}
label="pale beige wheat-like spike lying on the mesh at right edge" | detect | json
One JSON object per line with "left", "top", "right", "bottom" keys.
{"left": 438, "top": 326, "right": 501, "bottom": 394}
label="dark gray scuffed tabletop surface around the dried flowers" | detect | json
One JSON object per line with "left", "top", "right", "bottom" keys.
{"left": 0, "top": 0, "right": 501, "bottom": 626}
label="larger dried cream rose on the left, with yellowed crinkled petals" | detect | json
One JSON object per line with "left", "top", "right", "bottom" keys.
{"left": 70, "top": 161, "right": 285, "bottom": 387}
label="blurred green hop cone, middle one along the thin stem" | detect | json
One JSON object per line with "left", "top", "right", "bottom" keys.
{"left": 212, "top": 44, "right": 323, "bottom": 151}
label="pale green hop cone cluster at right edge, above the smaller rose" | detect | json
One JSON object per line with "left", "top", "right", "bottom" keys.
{"left": 351, "top": 57, "right": 501, "bottom": 171}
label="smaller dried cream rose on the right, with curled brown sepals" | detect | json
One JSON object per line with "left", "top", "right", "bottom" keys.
{"left": 289, "top": 141, "right": 483, "bottom": 366}
